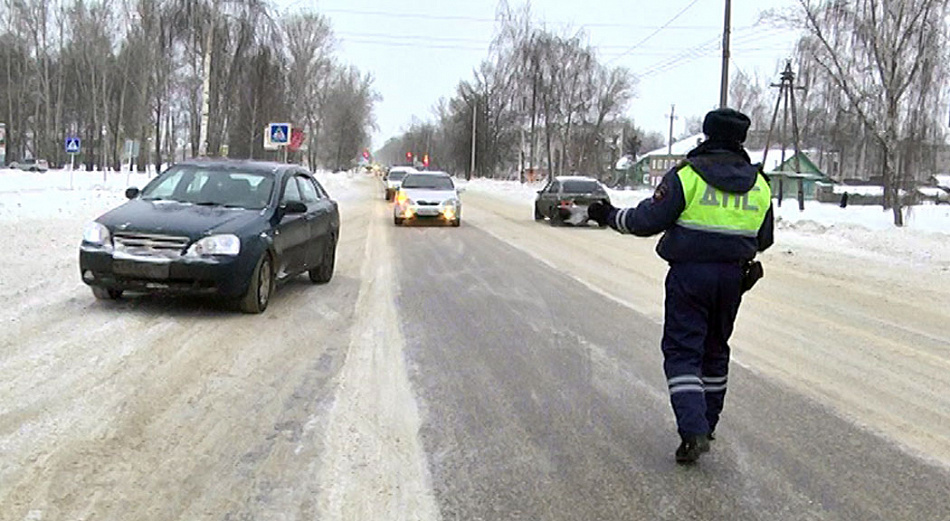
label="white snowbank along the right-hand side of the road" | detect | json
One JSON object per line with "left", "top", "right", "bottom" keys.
{"left": 461, "top": 179, "right": 950, "bottom": 271}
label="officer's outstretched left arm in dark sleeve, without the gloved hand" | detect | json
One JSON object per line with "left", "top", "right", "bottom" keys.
{"left": 607, "top": 168, "right": 686, "bottom": 237}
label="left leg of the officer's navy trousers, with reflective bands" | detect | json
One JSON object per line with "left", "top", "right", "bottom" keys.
{"left": 662, "top": 265, "right": 709, "bottom": 436}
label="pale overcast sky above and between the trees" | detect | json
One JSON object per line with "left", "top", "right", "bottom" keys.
{"left": 280, "top": 0, "right": 796, "bottom": 148}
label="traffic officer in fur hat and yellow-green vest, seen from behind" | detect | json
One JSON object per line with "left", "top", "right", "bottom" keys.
{"left": 588, "top": 109, "right": 773, "bottom": 463}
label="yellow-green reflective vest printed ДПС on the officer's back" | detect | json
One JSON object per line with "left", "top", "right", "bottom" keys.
{"left": 676, "top": 165, "right": 772, "bottom": 237}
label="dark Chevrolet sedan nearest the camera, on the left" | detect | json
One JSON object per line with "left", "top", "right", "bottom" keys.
{"left": 79, "top": 160, "right": 340, "bottom": 313}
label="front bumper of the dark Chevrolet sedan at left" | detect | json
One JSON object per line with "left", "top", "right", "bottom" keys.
{"left": 79, "top": 246, "right": 256, "bottom": 298}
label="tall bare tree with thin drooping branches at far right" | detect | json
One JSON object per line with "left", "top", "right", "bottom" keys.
{"left": 796, "top": 0, "right": 948, "bottom": 226}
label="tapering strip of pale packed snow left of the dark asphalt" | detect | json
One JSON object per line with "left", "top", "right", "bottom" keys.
{"left": 318, "top": 200, "right": 440, "bottom": 521}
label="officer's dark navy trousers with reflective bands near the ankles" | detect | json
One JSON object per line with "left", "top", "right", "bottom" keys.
{"left": 661, "top": 263, "right": 742, "bottom": 436}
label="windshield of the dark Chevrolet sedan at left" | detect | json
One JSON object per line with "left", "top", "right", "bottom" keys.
{"left": 142, "top": 166, "right": 274, "bottom": 210}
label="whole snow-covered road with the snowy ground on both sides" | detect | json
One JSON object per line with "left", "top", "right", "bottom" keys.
{"left": 0, "top": 173, "right": 950, "bottom": 521}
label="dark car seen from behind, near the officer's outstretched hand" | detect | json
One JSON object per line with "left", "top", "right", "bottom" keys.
{"left": 534, "top": 176, "right": 610, "bottom": 226}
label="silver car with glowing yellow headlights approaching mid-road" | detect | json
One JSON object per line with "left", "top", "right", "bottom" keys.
{"left": 393, "top": 172, "right": 462, "bottom": 226}
